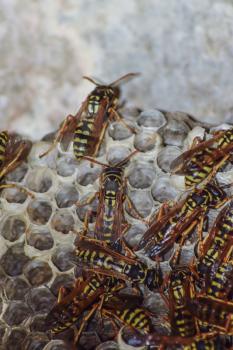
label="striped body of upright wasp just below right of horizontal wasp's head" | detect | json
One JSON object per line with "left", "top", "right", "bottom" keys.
{"left": 169, "top": 267, "right": 196, "bottom": 337}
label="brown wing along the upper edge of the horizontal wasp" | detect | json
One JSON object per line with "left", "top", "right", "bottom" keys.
{"left": 77, "top": 238, "right": 138, "bottom": 265}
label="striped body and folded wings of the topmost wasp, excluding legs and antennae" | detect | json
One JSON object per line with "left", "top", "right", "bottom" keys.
{"left": 73, "top": 86, "right": 119, "bottom": 160}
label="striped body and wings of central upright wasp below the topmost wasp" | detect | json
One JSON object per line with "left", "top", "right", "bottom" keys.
{"left": 95, "top": 167, "right": 126, "bottom": 251}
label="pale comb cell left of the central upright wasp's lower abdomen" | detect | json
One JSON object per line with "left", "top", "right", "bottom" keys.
{"left": 51, "top": 209, "right": 74, "bottom": 234}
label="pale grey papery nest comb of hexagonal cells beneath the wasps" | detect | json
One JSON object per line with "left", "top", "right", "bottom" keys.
{"left": 0, "top": 109, "right": 229, "bottom": 350}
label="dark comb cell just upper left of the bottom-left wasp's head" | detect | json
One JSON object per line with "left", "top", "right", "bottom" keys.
{"left": 27, "top": 287, "right": 56, "bottom": 314}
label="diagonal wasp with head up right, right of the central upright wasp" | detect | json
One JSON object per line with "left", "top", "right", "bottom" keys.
{"left": 135, "top": 182, "right": 228, "bottom": 260}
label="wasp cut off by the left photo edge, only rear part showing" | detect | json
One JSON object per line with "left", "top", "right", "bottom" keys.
{"left": 0, "top": 131, "right": 33, "bottom": 197}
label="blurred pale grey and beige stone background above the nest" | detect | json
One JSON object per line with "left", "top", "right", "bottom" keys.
{"left": 0, "top": 0, "right": 233, "bottom": 139}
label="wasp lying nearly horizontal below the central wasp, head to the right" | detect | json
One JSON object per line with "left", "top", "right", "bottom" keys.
{"left": 74, "top": 239, "right": 162, "bottom": 290}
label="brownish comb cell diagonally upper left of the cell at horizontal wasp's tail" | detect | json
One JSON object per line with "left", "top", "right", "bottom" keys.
{"left": 27, "top": 227, "right": 54, "bottom": 250}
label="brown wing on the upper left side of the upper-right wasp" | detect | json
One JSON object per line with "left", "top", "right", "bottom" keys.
{"left": 170, "top": 133, "right": 226, "bottom": 175}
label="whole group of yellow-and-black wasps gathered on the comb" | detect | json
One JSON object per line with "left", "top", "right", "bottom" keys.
{"left": 0, "top": 73, "right": 233, "bottom": 350}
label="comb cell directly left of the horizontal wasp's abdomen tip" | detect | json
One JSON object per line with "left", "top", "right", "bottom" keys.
{"left": 52, "top": 246, "right": 73, "bottom": 272}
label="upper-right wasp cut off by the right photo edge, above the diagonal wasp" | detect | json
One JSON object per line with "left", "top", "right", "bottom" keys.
{"left": 171, "top": 128, "right": 233, "bottom": 189}
